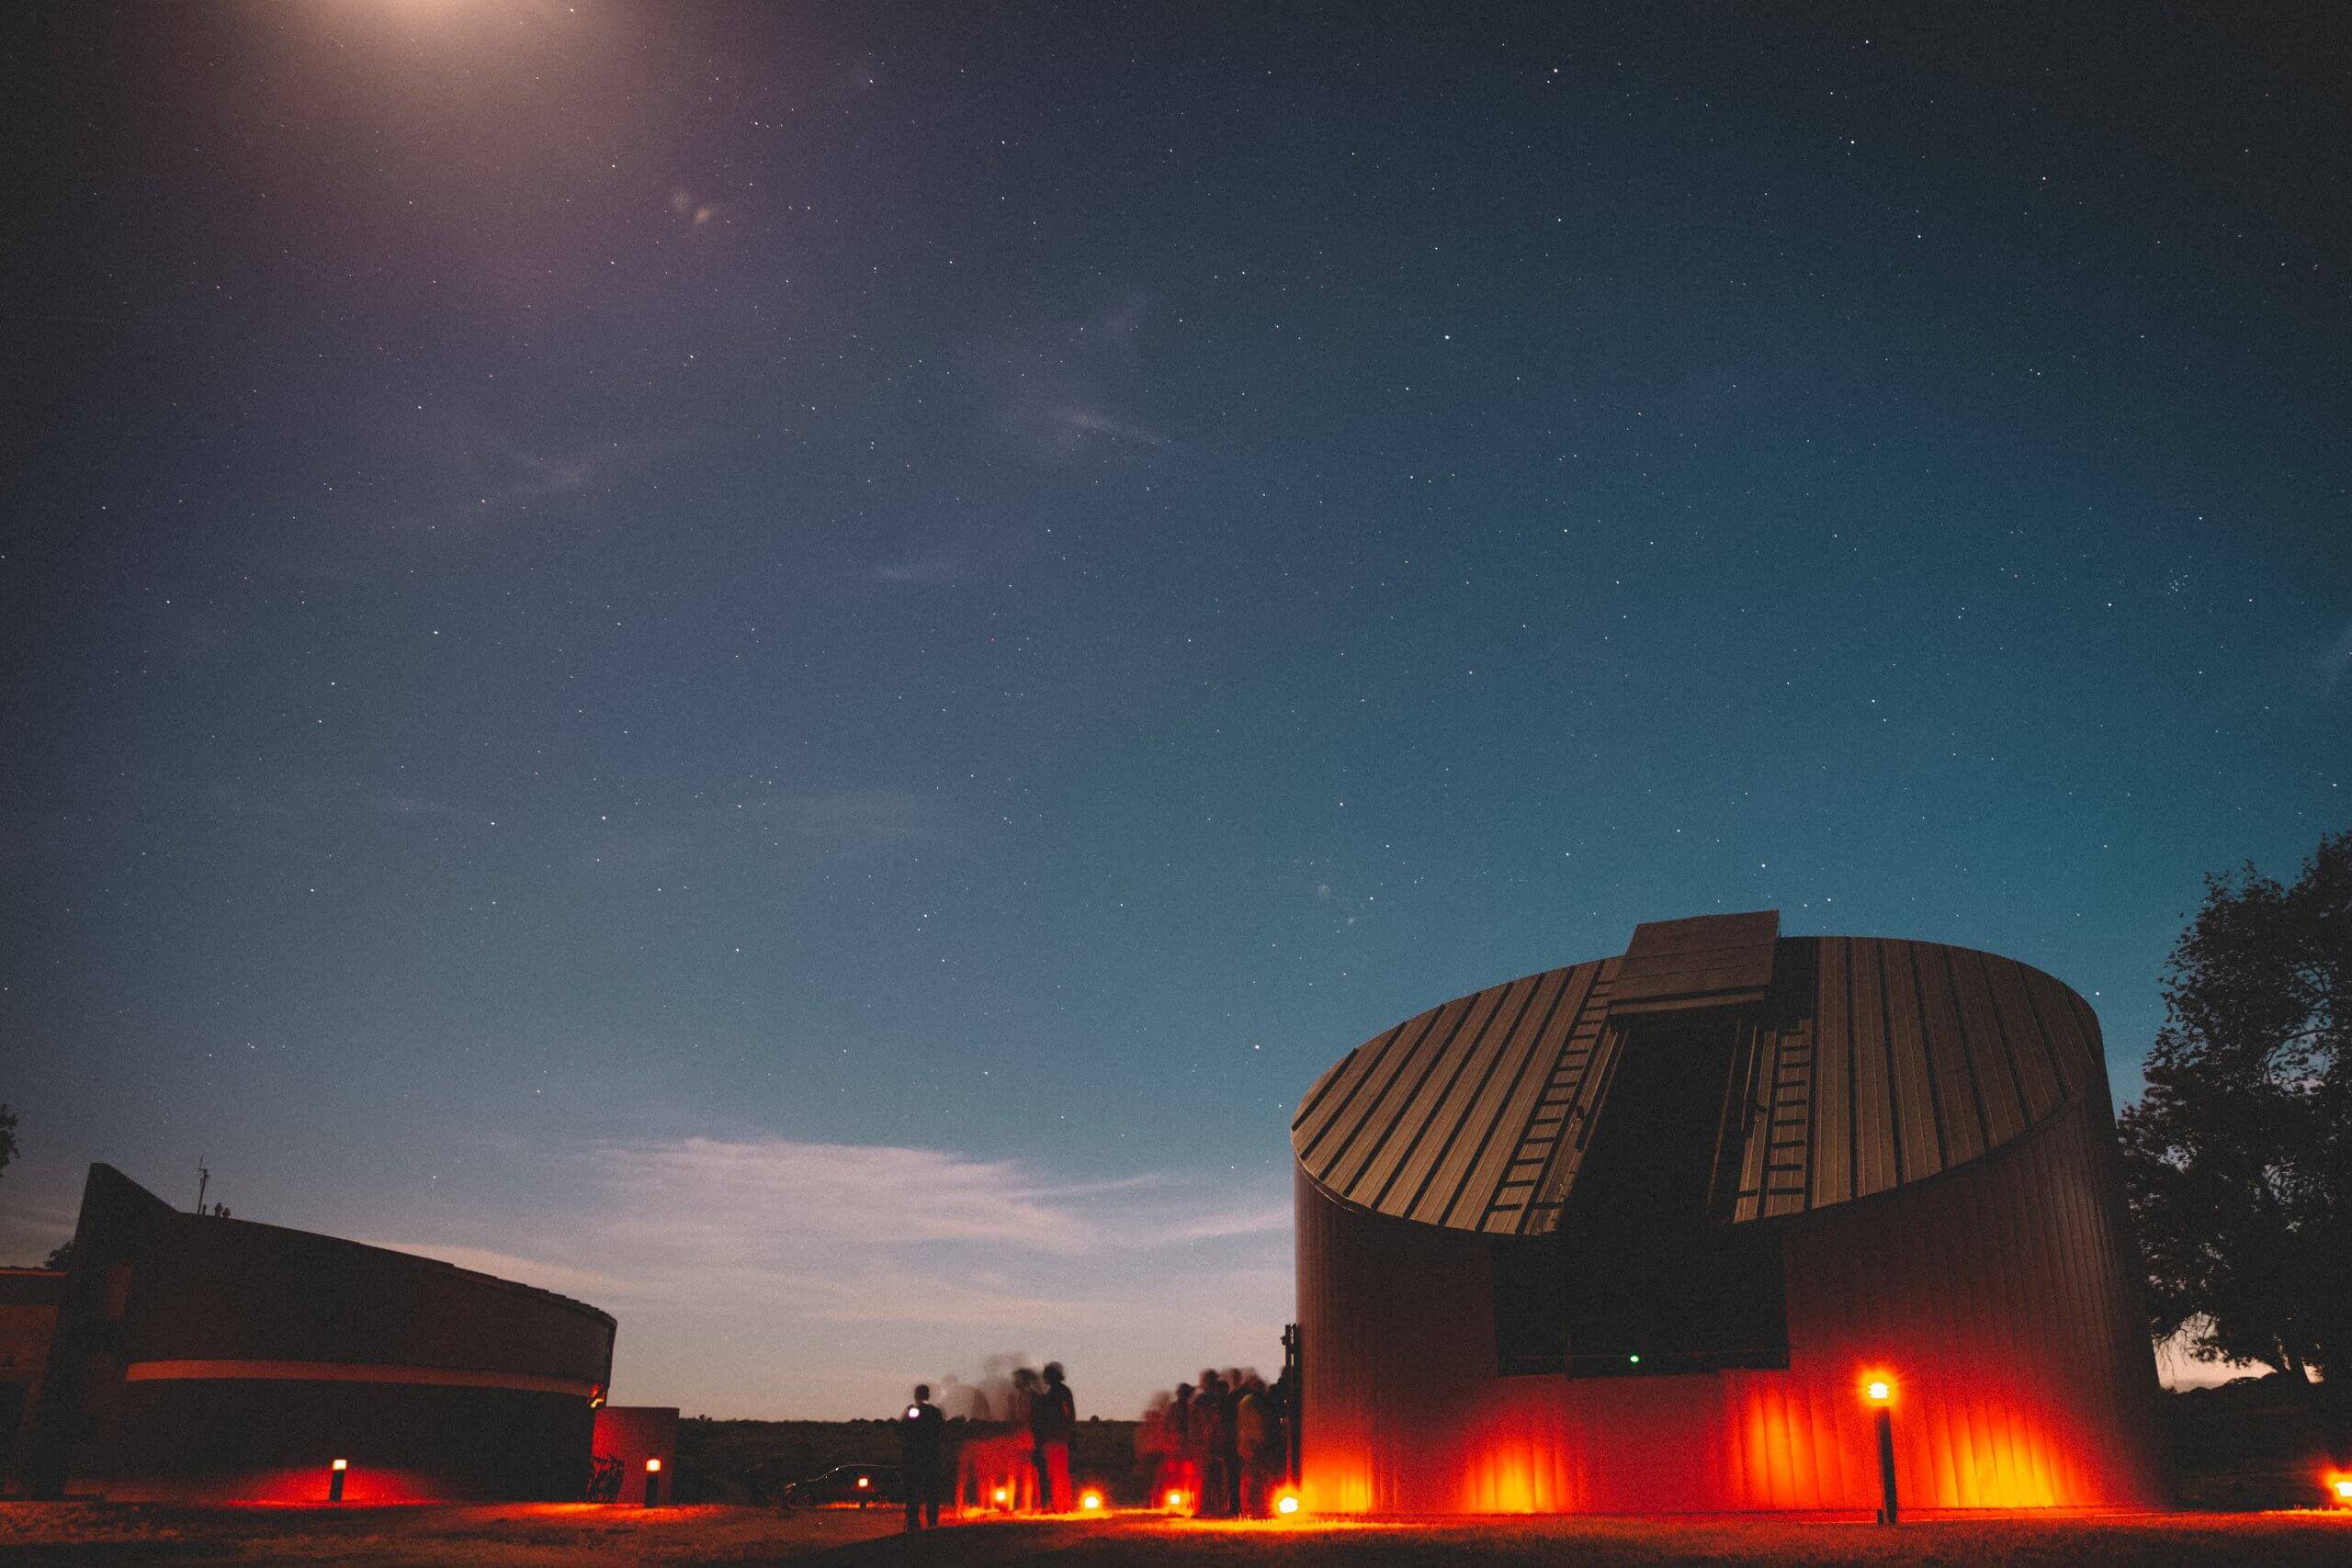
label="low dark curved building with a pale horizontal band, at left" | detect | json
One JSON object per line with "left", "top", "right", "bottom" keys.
{"left": 9, "top": 1166, "right": 614, "bottom": 1502}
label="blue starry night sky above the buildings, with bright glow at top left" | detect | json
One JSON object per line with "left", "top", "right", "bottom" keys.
{"left": 0, "top": 0, "right": 2352, "bottom": 1416}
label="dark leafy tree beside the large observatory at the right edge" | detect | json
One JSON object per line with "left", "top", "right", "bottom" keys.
{"left": 2121, "top": 829, "right": 2352, "bottom": 1382}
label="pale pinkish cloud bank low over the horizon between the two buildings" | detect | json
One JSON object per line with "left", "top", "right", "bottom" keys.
{"left": 379, "top": 1138, "right": 1289, "bottom": 1416}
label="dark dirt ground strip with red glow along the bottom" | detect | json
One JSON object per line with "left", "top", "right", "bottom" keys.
{"left": 0, "top": 1502, "right": 2352, "bottom": 1568}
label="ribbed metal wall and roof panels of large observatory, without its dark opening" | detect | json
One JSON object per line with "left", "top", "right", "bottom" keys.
{"left": 1296, "top": 938, "right": 2164, "bottom": 1514}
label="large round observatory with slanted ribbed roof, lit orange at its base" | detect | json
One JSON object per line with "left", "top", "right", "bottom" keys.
{"left": 1291, "top": 909, "right": 2162, "bottom": 1514}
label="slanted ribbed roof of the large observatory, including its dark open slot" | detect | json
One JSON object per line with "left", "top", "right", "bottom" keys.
{"left": 1291, "top": 909, "right": 2105, "bottom": 1375}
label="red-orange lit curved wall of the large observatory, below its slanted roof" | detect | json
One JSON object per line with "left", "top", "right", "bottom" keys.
{"left": 1296, "top": 1105, "right": 2162, "bottom": 1514}
